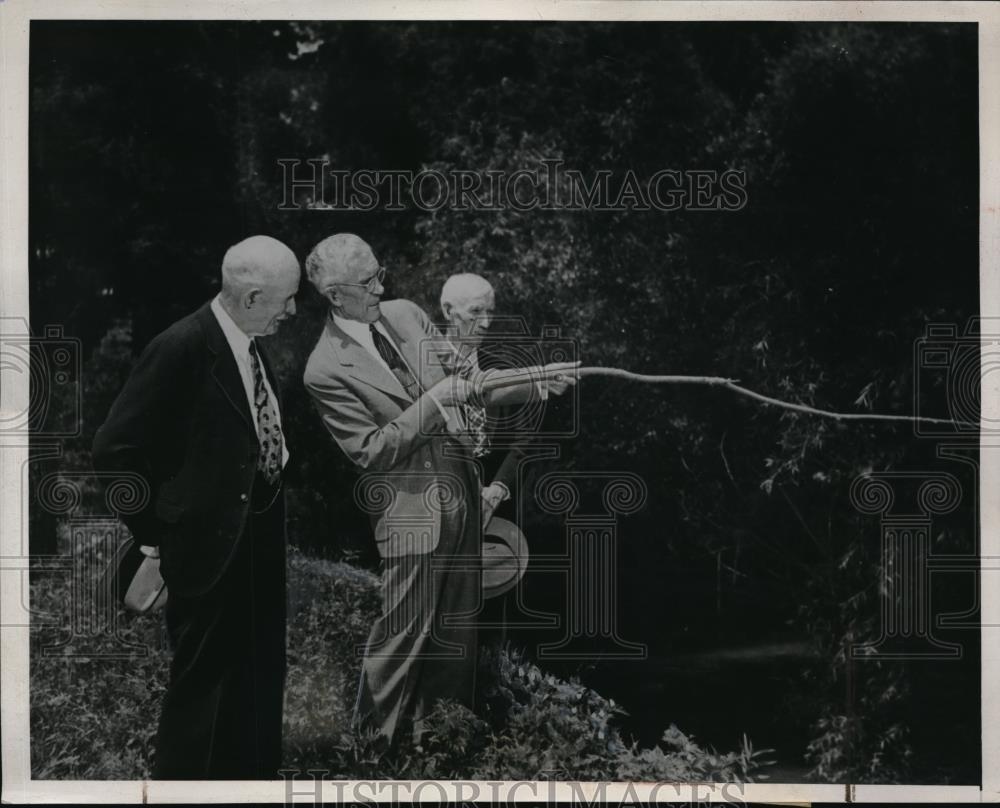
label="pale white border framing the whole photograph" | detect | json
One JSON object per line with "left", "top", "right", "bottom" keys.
{"left": 0, "top": 0, "right": 1000, "bottom": 803}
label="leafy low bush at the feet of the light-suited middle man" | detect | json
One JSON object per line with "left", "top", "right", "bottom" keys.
{"left": 320, "top": 650, "right": 771, "bottom": 782}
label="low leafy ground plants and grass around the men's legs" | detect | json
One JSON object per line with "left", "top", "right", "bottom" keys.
{"left": 31, "top": 536, "right": 768, "bottom": 782}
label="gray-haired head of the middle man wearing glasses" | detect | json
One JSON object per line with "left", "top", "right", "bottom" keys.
{"left": 306, "top": 233, "right": 385, "bottom": 323}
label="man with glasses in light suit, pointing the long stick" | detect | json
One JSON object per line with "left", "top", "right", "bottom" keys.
{"left": 305, "top": 233, "right": 572, "bottom": 739}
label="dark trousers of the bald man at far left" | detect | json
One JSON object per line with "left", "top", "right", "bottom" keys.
{"left": 153, "top": 476, "right": 286, "bottom": 780}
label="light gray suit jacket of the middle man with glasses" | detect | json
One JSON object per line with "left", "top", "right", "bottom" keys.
{"left": 304, "top": 300, "right": 516, "bottom": 558}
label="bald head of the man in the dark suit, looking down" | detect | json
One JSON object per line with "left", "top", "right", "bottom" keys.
{"left": 221, "top": 236, "right": 301, "bottom": 337}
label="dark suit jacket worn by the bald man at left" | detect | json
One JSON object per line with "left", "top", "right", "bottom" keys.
{"left": 93, "top": 303, "right": 278, "bottom": 595}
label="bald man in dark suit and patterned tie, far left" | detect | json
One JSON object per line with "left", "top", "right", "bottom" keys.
{"left": 93, "top": 236, "right": 301, "bottom": 780}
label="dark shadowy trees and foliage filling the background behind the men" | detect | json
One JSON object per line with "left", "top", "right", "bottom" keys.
{"left": 30, "top": 21, "right": 979, "bottom": 782}
